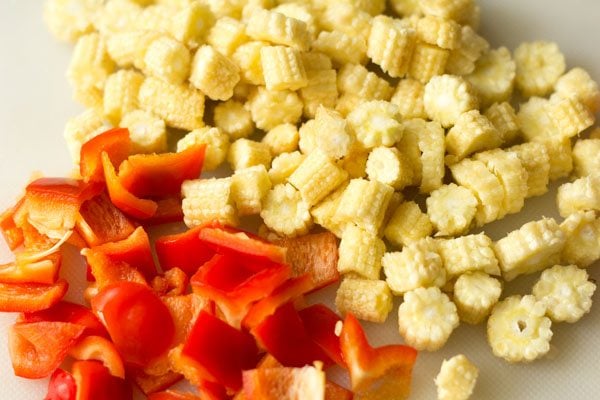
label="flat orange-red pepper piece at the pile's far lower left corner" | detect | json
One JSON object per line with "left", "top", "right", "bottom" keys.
{"left": 8, "top": 321, "right": 85, "bottom": 379}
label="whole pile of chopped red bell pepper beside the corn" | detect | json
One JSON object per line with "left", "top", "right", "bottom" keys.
{"left": 0, "top": 129, "right": 416, "bottom": 400}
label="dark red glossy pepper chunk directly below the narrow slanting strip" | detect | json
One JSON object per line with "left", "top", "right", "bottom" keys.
{"left": 251, "top": 303, "right": 333, "bottom": 367}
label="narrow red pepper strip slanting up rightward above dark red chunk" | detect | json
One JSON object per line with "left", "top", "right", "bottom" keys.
{"left": 242, "top": 274, "right": 314, "bottom": 329}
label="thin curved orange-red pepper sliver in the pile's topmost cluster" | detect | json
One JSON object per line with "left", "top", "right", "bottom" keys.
{"left": 102, "top": 152, "right": 158, "bottom": 219}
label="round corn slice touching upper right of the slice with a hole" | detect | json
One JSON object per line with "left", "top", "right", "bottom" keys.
{"left": 531, "top": 265, "right": 596, "bottom": 324}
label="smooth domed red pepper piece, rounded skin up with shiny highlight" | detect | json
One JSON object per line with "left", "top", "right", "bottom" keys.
{"left": 91, "top": 282, "right": 175, "bottom": 368}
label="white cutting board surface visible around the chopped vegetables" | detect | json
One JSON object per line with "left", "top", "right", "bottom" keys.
{"left": 0, "top": 0, "right": 600, "bottom": 400}
